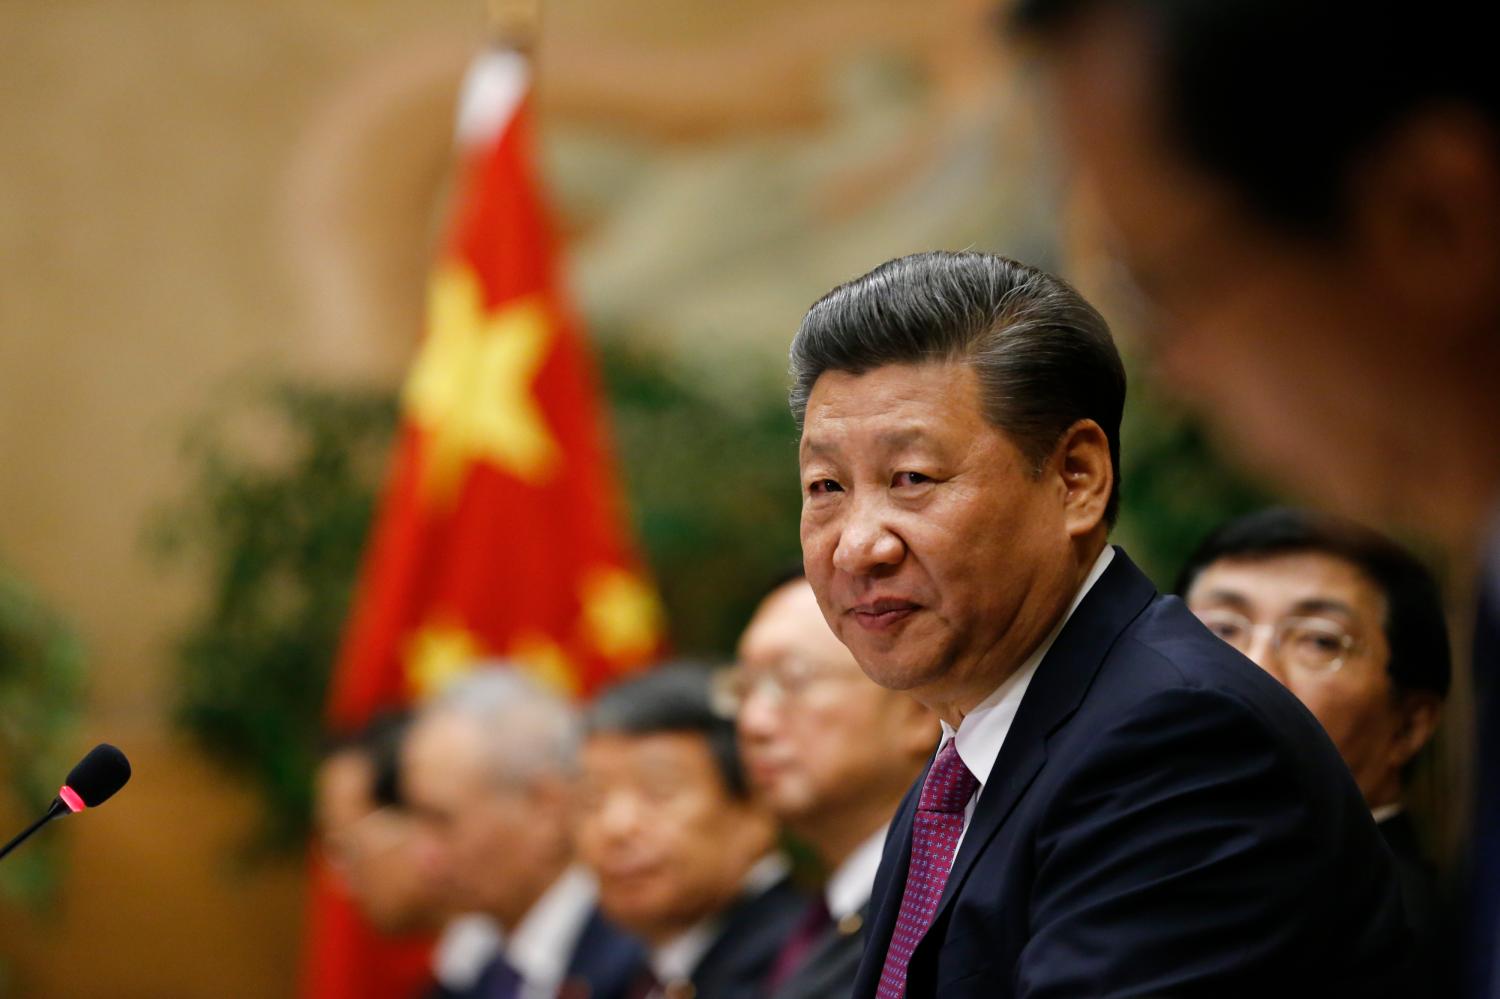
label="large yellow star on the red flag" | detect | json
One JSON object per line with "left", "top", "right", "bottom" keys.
{"left": 402, "top": 263, "right": 560, "bottom": 500}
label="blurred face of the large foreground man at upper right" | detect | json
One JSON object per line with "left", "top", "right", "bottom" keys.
{"left": 1055, "top": 12, "right": 1431, "bottom": 521}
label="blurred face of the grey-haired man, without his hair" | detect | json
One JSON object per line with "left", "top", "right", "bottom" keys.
{"left": 402, "top": 714, "right": 564, "bottom": 926}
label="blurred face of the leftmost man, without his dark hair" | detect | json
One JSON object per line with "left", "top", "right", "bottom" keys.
{"left": 317, "top": 752, "right": 441, "bottom": 933}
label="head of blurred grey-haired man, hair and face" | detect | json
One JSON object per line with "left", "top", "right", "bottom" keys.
{"left": 402, "top": 663, "right": 579, "bottom": 927}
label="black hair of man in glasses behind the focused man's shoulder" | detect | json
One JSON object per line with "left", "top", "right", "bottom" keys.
{"left": 1178, "top": 507, "right": 1452, "bottom": 698}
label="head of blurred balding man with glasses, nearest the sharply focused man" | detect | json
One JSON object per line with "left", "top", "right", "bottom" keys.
{"left": 723, "top": 576, "right": 939, "bottom": 863}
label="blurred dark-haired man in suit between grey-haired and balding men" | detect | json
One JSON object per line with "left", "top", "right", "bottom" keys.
{"left": 578, "top": 665, "right": 806, "bottom": 999}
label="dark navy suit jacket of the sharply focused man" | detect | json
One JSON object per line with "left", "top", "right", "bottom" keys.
{"left": 854, "top": 551, "right": 1409, "bottom": 999}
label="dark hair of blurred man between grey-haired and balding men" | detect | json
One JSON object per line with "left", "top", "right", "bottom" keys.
{"left": 584, "top": 662, "right": 749, "bottom": 798}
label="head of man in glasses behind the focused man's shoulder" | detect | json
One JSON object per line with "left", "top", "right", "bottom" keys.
{"left": 1178, "top": 509, "right": 1451, "bottom": 807}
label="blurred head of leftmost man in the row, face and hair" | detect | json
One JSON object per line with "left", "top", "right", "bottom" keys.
{"left": 315, "top": 716, "right": 443, "bottom": 933}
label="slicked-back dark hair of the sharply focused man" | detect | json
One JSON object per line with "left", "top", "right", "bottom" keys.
{"left": 791, "top": 252, "right": 1125, "bottom": 524}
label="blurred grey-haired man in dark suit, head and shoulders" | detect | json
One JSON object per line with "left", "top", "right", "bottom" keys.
{"left": 402, "top": 665, "right": 641, "bottom": 999}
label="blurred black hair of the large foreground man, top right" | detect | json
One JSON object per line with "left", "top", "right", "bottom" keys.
{"left": 1011, "top": 0, "right": 1500, "bottom": 236}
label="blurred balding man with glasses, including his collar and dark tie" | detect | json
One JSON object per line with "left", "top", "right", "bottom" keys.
{"left": 725, "top": 575, "right": 939, "bottom": 999}
